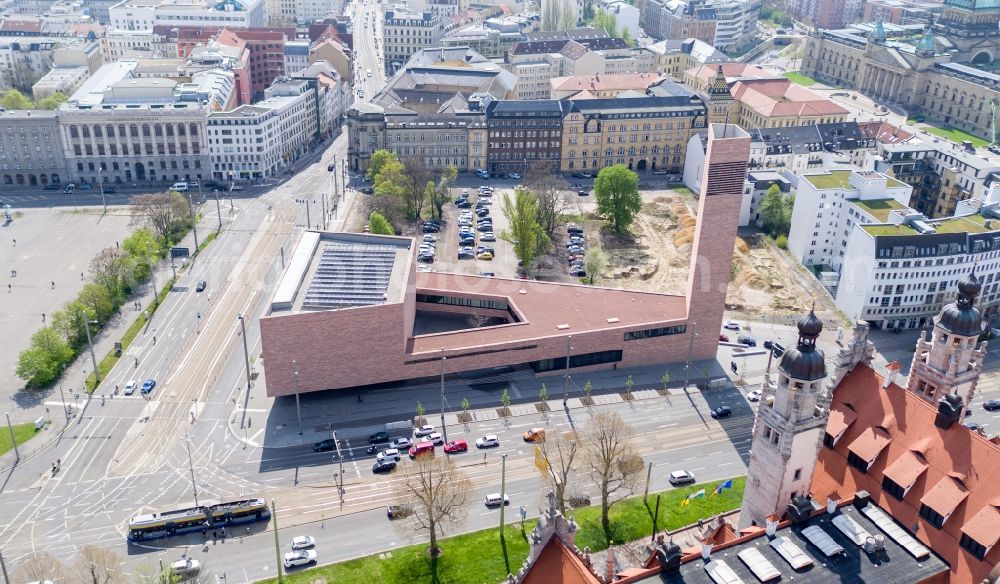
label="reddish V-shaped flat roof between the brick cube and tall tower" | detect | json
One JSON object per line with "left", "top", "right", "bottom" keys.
{"left": 407, "top": 272, "right": 687, "bottom": 355}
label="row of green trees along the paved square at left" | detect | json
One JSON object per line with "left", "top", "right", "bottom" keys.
{"left": 15, "top": 192, "right": 191, "bottom": 388}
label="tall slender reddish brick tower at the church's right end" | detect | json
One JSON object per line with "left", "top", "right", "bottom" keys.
{"left": 687, "top": 124, "right": 750, "bottom": 361}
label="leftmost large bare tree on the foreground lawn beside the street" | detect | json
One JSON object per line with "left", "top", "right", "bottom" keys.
{"left": 396, "top": 455, "right": 472, "bottom": 557}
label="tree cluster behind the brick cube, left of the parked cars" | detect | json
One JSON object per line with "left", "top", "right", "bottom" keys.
{"left": 367, "top": 150, "right": 458, "bottom": 227}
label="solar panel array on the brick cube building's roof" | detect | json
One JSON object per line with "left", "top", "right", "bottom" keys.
{"left": 302, "top": 243, "right": 396, "bottom": 310}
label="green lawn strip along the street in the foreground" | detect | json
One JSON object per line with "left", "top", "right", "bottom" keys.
{"left": 267, "top": 477, "right": 746, "bottom": 584}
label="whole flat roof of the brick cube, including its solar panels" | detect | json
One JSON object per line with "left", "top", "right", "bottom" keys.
{"left": 271, "top": 230, "right": 413, "bottom": 315}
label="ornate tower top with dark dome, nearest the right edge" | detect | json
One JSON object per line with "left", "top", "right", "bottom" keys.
{"left": 907, "top": 269, "right": 986, "bottom": 407}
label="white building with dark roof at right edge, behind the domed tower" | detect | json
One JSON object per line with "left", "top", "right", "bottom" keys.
{"left": 836, "top": 199, "right": 1000, "bottom": 329}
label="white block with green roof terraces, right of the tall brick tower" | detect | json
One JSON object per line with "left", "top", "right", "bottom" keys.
{"left": 786, "top": 167, "right": 913, "bottom": 274}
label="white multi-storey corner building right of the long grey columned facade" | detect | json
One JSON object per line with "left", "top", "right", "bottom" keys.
{"left": 208, "top": 81, "right": 319, "bottom": 180}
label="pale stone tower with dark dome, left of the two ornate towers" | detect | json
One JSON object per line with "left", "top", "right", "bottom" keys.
{"left": 740, "top": 310, "right": 830, "bottom": 527}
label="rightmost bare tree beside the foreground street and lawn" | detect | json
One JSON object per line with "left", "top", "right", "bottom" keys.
{"left": 583, "top": 412, "right": 644, "bottom": 532}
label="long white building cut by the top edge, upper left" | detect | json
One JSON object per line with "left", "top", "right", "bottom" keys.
{"left": 108, "top": 0, "right": 268, "bottom": 30}
